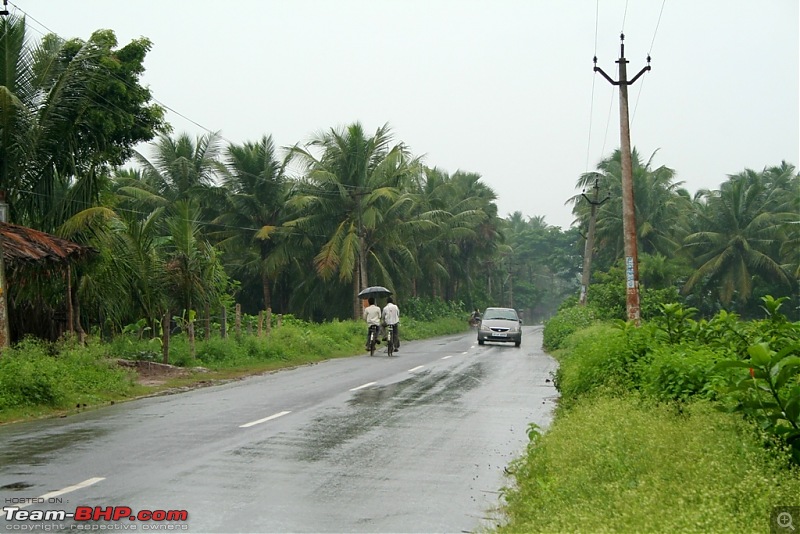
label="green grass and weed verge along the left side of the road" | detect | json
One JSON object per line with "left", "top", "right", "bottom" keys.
{"left": 0, "top": 316, "right": 467, "bottom": 424}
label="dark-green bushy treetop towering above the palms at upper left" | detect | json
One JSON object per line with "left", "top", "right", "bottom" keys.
{"left": 0, "top": 16, "right": 167, "bottom": 232}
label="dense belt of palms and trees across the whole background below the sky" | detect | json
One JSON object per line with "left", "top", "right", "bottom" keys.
{"left": 0, "top": 17, "right": 800, "bottom": 348}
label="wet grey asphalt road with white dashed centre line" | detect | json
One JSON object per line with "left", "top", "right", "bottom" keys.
{"left": 0, "top": 326, "right": 556, "bottom": 532}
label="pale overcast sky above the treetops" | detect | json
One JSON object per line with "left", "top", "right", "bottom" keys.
{"left": 9, "top": 0, "right": 800, "bottom": 229}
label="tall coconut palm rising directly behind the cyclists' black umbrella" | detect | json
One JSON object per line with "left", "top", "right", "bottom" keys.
{"left": 285, "top": 123, "right": 415, "bottom": 318}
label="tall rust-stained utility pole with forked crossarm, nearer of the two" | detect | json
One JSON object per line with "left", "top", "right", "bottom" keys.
{"left": 594, "top": 34, "right": 650, "bottom": 326}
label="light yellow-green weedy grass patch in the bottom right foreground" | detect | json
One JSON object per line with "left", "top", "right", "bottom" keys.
{"left": 497, "top": 394, "right": 800, "bottom": 533}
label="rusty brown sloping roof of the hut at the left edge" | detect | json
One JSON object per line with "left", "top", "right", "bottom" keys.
{"left": 0, "top": 223, "right": 94, "bottom": 263}
